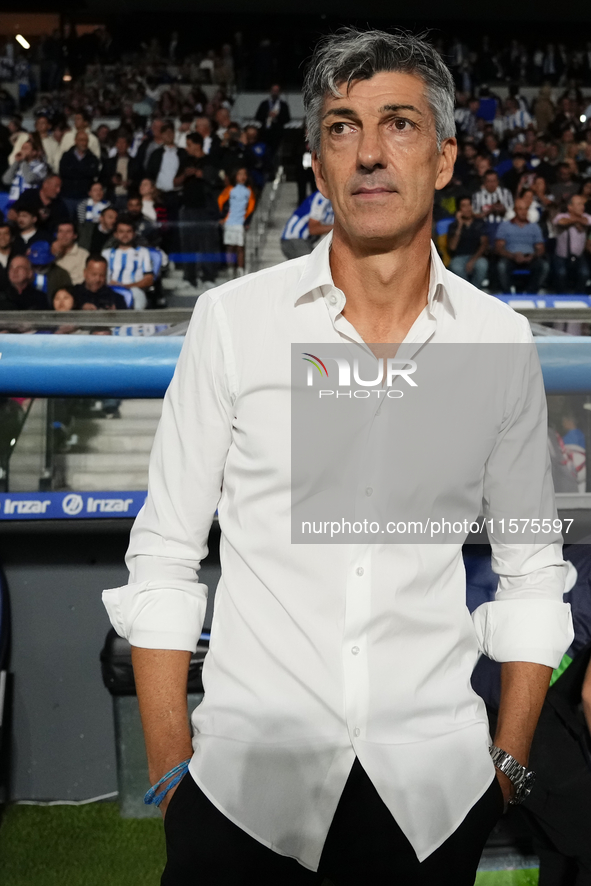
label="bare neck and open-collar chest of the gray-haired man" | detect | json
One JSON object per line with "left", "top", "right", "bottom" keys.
{"left": 330, "top": 221, "right": 431, "bottom": 343}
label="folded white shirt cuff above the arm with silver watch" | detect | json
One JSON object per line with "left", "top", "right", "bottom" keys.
{"left": 472, "top": 599, "right": 574, "bottom": 668}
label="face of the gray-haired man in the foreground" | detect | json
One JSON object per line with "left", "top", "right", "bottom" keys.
{"left": 312, "top": 72, "right": 456, "bottom": 246}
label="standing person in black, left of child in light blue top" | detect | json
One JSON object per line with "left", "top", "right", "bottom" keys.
{"left": 177, "top": 132, "right": 220, "bottom": 286}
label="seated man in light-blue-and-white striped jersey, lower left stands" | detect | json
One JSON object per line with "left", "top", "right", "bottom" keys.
{"left": 103, "top": 215, "right": 154, "bottom": 311}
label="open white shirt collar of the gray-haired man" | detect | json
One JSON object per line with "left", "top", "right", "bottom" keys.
{"left": 293, "top": 231, "right": 457, "bottom": 317}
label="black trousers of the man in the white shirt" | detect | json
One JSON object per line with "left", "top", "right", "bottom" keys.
{"left": 161, "top": 760, "right": 503, "bottom": 886}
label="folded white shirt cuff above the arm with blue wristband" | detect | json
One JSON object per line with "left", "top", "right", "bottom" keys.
{"left": 103, "top": 581, "right": 207, "bottom": 652}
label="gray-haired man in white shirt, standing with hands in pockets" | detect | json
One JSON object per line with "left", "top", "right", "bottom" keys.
{"left": 103, "top": 29, "right": 572, "bottom": 886}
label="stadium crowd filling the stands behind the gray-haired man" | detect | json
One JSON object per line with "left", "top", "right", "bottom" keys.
{"left": 0, "top": 26, "right": 591, "bottom": 320}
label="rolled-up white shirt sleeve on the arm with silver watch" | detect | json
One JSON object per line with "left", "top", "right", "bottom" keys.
{"left": 472, "top": 330, "right": 573, "bottom": 668}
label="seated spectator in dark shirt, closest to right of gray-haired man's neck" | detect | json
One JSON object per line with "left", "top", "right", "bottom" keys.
{"left": 447, "top": 197, "right": 488, "bottom": 289}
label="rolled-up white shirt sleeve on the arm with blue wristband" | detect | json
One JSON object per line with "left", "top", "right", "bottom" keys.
{"left": 103, "top": 295, "right": 234, "bottom": 651}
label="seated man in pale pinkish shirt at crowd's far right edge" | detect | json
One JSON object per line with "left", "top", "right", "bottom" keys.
{"left": 553, "top": 194, "right": 591, "bottom": 293}
